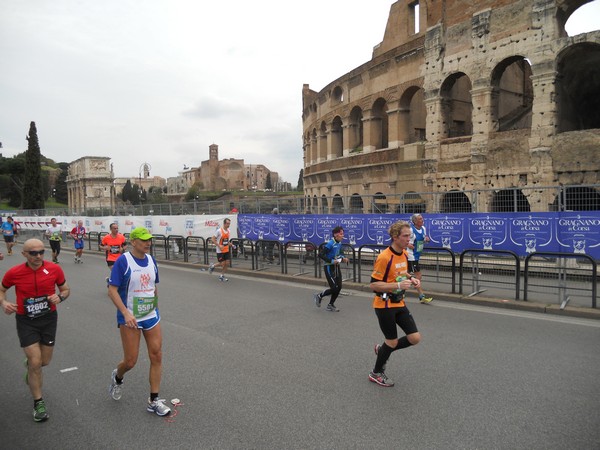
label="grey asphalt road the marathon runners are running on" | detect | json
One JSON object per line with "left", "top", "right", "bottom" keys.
{"left": 0, "top": 253, "right": 600, "bottom": 449}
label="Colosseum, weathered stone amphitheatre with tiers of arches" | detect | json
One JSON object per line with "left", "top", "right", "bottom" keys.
{"left": 302, "top": 0, "right": 600, "bottom": 213}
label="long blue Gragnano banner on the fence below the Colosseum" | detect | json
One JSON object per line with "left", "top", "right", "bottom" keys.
{"left": 238, "top": 211, "right": 600, "bottom": 260}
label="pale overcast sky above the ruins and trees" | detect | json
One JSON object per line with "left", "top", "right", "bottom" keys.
{"left": 0, "top": 0, "right": 600, "bottom": 186}
